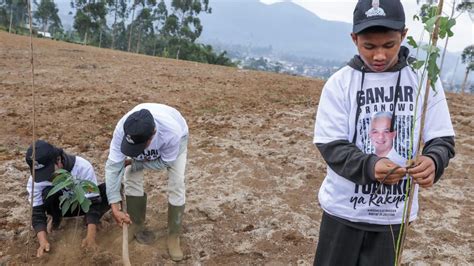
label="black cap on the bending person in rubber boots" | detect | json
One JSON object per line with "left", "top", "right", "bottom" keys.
{"left": 120, "top": 109, "right": 155, "bottom": 157}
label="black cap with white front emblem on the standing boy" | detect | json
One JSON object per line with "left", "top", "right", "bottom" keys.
{"left": 352, "top": 0, "right": 405, "bottom": 34}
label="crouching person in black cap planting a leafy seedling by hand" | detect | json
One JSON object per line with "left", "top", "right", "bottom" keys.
{"left": 25, "top": 140, "right": 110, "bottom": 257}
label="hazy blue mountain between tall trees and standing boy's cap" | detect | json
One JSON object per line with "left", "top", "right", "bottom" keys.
{"left": 199, "top": 0, "right": 355, "bottom": 61}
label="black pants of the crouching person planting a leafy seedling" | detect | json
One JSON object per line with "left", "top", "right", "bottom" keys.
{"left": 42, "top": 183, "right": 110, "bottom": 229}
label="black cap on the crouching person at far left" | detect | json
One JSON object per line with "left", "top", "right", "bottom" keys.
{"left": 25, "top": 140, "right": 61, "bottom": 182}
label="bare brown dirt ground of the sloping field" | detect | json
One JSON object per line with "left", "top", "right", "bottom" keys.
{"left": 0, "top": 32, "right": 474, "bottom": 265}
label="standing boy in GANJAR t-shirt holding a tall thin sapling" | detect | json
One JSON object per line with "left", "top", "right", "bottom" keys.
{"left": 313, "top": 0, "right": 454, "bottom": 265}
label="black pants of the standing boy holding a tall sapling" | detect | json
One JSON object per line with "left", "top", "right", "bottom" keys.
{"left": 314, "top": 213, "right": 399, "bottom": 266}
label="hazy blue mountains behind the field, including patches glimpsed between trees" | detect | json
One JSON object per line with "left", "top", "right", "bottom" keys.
{"left": 52, "top": 0, "right": 474, "bottom": 83}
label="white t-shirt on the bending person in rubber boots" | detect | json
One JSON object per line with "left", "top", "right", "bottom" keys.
{"left": 109, "top": 103, "right": 188, "bottom": 162}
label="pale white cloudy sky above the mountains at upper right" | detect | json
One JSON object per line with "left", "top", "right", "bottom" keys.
{"left": 260, "top": 0, "right": 474, "bottom": 52}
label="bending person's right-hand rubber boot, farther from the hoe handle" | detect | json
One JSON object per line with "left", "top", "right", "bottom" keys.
{"left": 166, "top": 203, "right": 184, "bottom": 261}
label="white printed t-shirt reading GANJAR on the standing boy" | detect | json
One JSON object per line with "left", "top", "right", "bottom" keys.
{"left": 313, "top": 66, "right": 454, "bottom": 225}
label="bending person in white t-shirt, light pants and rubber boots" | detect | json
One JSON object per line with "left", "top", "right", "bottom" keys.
{"left": 105, "top": 103, "right": 188, "bottom": 261}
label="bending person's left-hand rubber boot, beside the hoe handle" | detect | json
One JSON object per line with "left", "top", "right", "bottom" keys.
{"left": 126, "top": 193, "right": 155, "bottom": 245}
